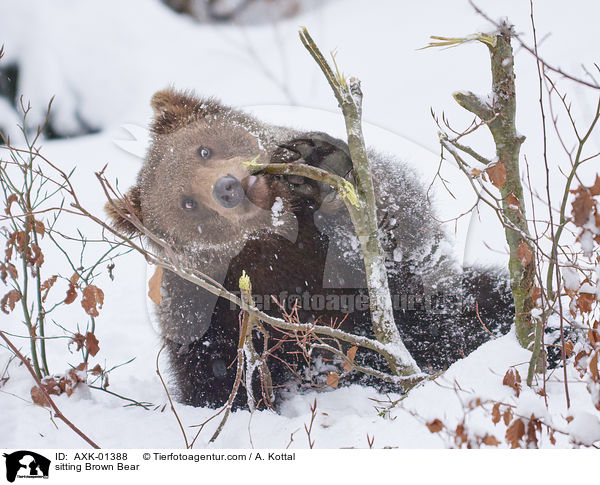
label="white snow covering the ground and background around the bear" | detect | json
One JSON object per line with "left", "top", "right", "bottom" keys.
{"left": 0, "top": 0, "right": 600, "bottom": 448}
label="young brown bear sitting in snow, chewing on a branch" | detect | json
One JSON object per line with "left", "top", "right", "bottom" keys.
{"left": 107, "top": 89, "right": 513, "bottom": 406}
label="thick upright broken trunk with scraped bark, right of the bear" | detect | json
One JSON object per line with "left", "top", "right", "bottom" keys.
{"left": 454, "top": 24, "right": 535, "bottom": 348}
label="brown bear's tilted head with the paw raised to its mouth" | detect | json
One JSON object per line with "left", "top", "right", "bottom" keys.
{"left": 106, "top": 89, "right": 351, "bottom": 255}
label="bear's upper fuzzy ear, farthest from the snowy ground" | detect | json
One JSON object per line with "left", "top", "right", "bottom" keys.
{"left": 150, "top": 88, "right": 220, "bottom": 134}
